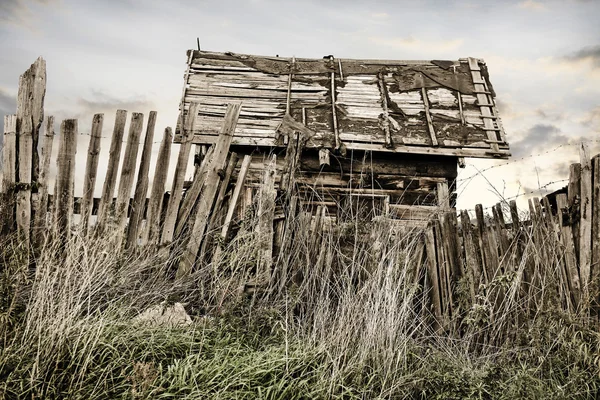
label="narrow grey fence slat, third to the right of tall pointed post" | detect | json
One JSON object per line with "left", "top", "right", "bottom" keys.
{"left": 81, "top": 114, "right": 104, "bottom": 235}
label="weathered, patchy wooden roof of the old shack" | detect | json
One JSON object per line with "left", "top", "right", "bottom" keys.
{"left": 175, "top": 50, "right": 510, "bottom": 158}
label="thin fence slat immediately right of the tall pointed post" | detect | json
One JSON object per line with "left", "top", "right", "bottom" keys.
{"left": 33, "top": 116, "right": 54, "bottom": 246}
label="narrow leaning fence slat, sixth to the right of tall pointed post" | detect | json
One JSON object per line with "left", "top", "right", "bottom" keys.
{"left": 125, "top": 111, "right": 156, "bottom": 248}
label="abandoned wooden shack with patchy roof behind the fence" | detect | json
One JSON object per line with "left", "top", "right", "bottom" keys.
{"left": 175, "top": 50, "right": 510, "bottom": 225}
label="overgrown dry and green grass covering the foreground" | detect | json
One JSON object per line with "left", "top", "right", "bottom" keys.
{"left": 0, "top": 209, "right": 600, "bottom": 399}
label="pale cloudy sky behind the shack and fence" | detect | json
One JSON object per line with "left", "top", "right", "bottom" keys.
{"left": 0, "top": 0, "right": 600, "bottom": 212}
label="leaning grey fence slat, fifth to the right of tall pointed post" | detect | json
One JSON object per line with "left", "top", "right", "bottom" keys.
{"left": 114, "top": 113, "right": 144, "bottom": 247}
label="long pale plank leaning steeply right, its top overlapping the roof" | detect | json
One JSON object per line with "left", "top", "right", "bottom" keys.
{"left": 177, "top": 104, "right": 241, "bottom": 276}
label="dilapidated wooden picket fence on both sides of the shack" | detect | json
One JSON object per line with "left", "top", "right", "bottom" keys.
{"left": 1, "top": 59, "right": 600, "bottom": 321}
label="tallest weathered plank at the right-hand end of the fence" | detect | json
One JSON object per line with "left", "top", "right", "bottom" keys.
{"left": 579, "top": 143, "right": 593, "bottom": 295}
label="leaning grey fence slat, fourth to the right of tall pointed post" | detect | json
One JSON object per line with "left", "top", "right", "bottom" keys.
{"left": 96, "top": 110, "right": 127, "bottom": 233}
